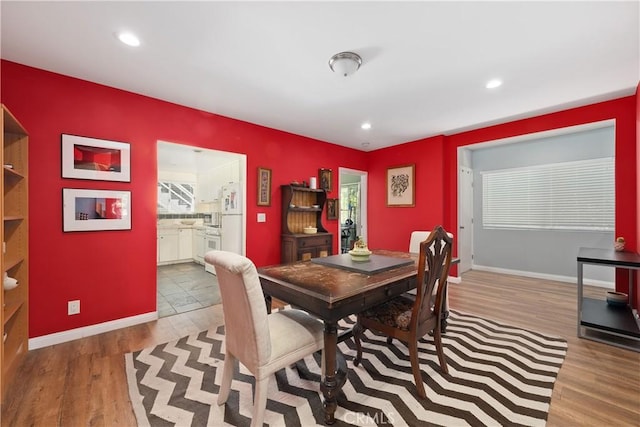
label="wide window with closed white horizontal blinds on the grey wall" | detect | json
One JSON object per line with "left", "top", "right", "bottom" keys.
{"left": 481, "top": 157, "right": 615, "bottom": 231}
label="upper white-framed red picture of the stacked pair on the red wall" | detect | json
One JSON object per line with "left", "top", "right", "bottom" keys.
{"left": 62, "top": 133, "right": 131, "bottom": 182}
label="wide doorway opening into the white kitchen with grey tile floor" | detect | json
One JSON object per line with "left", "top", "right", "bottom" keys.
{"left": 156, "top": 141, "right": 247, "bottom": 317}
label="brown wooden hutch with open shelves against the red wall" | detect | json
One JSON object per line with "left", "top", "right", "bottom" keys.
{"left": 280, "top": 185, "right": 333, "bottom": 263}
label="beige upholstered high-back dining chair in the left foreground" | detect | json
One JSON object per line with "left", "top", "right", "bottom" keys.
{"left": 204, "top": 251, "right": 324, "bottom": 427}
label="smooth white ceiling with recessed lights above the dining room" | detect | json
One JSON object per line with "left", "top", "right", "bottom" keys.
{"left": 0, "top": 0, "right": 640, "bottom": 151}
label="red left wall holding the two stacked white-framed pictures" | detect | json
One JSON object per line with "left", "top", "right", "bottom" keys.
{"left": 0, "top": 61, "right": 367, "bottom": 337}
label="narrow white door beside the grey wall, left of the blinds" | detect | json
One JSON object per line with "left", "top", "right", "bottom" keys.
{"left": 458, "top": 166, "right": 473, "bottom": 274}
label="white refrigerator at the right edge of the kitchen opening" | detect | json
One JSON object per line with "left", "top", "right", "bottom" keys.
{"left": 220, "top": 182, "right": 244, "bottom": 255}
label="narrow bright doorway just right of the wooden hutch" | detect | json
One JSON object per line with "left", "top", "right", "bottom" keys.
{"left": 338, "top": 168, "right": 368, "bottom": 253}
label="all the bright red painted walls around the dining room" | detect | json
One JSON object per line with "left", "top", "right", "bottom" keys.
{"left": 0, "top": 61, "right": 640, "bottom": 337}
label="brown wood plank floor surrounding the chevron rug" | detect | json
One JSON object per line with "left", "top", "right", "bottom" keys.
{"left": 1, "top": 271, "right": 640, "bottom": 427}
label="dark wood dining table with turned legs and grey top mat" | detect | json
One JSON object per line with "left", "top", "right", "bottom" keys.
{"left": 258, "top": 250, "right": 457, "bottom": 424}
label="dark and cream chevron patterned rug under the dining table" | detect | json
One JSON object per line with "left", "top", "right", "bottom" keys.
{"left": 125, "top": 311, "right": 567, "bottom": 427}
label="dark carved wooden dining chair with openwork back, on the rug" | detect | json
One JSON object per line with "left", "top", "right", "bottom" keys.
{"left": 353, "top": 226, "right": 453, "bottom": 398}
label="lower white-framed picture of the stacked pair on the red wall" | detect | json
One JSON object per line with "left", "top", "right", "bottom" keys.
{"left": 62, "top": 188, "right": 131, "bottom": 231}
